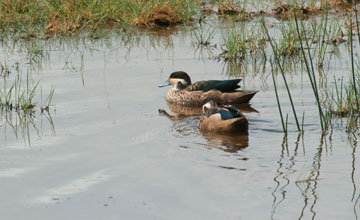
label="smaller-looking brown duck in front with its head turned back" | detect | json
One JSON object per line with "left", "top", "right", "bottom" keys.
{"left": 198, "top": 100, "right": 249, "bottom": 133}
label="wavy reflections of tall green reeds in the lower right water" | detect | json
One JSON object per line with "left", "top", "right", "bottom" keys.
{"left": 270, "top": 131, "right": 360, "bottom": 219}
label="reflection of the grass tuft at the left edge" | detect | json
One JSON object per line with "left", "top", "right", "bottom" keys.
{"left": 0, "top": 110, "right": 55, "bottom": 146}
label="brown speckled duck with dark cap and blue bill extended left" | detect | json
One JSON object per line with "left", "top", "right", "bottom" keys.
{"left": 158, "top": 71, "right": 257, "bottom": 106}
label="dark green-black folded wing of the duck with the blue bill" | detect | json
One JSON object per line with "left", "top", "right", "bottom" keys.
{"left": 186, "top": 79, "right": 241, "bottom": 92}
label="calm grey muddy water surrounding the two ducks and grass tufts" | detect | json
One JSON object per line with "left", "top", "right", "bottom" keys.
{"left": 0, "top": 23, "right": 360, "bottom": 219}
